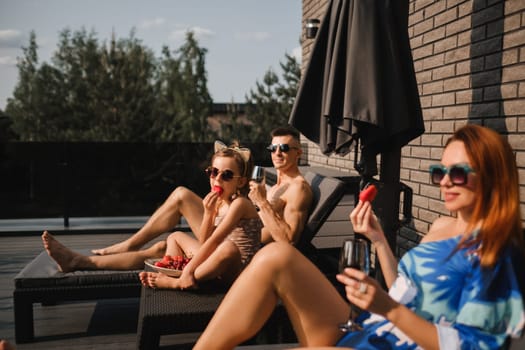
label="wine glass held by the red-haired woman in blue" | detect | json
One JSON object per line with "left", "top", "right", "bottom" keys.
{"left": 339, "top": 238, "right": 370, "bottom": 332}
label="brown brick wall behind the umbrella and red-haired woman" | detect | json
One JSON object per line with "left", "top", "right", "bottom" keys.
{"left": 303, "top": 0, "right": 525, "bottom": 234}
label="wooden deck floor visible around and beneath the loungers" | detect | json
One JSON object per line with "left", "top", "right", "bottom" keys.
{"left": 0, "top": 234, "right": 207, "bottom": 350}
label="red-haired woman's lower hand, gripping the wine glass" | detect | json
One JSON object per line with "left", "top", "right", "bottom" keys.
{"left": 336, "top": 268, "right": 398, "bottom": 316}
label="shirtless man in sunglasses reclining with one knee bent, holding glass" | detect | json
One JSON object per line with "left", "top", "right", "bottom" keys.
{"left": 93, "top": 127, "right": 313, "bottom": 255}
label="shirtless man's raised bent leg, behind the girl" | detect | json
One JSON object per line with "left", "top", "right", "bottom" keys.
{"left": 92, "top": 186, "right": 204, "bottom": 255}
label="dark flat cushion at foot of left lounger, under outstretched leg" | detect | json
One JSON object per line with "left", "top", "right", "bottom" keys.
{"left": 15, "top": 250, "right": 142, "bottom": 288}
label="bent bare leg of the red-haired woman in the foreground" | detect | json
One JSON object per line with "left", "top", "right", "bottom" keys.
{"left": 194, "top": 243, "right": 350, "bottom": 350}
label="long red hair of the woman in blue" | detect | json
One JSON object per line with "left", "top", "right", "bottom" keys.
{"left": 446, "top": 124, "right": 523, "bottom": 267}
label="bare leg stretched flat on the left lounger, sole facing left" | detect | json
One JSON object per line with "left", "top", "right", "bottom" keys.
{"left": 42, "top": 231, "right": 166, "bottom": 272}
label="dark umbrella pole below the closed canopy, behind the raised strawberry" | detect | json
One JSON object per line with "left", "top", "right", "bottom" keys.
{"left": 375, "top": 148, "right": 401, "bottom": 285}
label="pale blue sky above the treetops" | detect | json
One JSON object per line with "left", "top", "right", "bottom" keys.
{"left": 0, "top": 0, "right": 302, "bottom": 109}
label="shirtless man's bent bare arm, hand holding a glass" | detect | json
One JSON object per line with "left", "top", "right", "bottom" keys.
{"left": 258, "top": 180, "right": 313, "bottom": 244}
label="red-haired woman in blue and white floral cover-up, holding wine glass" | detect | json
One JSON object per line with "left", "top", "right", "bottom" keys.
{"left": 194, "top": 125, "right": 525, "bottom": 350}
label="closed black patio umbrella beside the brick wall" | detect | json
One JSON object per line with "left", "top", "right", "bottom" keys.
{"left": 289, "top": 0, "right": 424, "bottom": 262}
